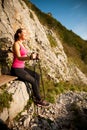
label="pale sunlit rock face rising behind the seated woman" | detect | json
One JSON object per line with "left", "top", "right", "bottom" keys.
{"left": 0, "top": 0, "right": 87, "bottom": 84}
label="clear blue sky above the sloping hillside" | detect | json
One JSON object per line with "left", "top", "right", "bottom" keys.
{"left": 30, "top": 0, "right": 87, "bottom": 40}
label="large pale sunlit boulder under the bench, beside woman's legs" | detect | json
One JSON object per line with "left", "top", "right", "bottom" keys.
{"left": 8, "top": 81, "right": 29, "bottom": 120}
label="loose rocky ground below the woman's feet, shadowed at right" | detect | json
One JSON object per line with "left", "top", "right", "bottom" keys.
{"left": 9, "top": 91, "right": 87, "bottom": 130}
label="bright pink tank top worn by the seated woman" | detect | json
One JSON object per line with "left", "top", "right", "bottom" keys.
{"left": 12, "top": 46, "right": 27, "bottom": 68}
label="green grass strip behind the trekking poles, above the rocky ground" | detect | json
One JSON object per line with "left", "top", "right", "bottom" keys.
{"left": 30, "top": 64, "right": 87, "bottom": 103}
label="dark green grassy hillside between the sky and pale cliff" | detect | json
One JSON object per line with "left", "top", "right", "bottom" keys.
{"left": 24, "top": 0, "right": 87, "bottom": 74}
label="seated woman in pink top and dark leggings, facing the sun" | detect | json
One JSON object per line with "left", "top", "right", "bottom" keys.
{"left": 11, "top": 28, "right": 48, "bottom": 106}
